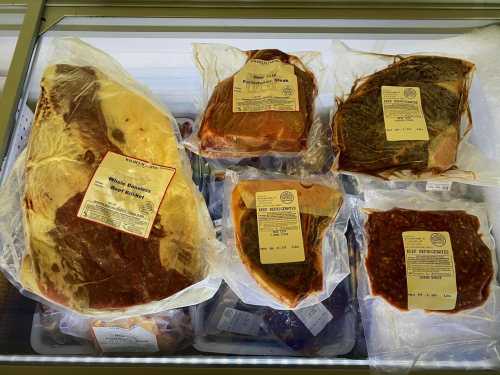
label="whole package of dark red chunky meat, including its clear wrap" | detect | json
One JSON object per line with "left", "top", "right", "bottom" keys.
{"left": 347, "top": 188, "right": 500, "bottom": 372}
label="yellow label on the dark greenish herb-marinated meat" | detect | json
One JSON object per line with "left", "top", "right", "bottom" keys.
{"left": 382, "top": 86, "right": 429, "bottom": 141}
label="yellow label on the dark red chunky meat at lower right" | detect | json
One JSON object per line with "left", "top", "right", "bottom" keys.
{"left": 403, "top": 231, "right": 457, "bottom": 310}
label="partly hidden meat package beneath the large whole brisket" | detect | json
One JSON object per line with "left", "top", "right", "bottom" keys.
{"left": 31, "top": 304, "right": 193, "bottom": 355}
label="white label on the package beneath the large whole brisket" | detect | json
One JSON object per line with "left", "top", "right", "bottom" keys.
{"left": 93, "top": 326, "right": 159, "bottom": 353}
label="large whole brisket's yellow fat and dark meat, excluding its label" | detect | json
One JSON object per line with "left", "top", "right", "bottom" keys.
{"left": 22, "top": 65, "right": 209, "bottom": 312}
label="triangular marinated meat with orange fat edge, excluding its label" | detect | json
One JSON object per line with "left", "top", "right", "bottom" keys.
{"left": 231, "top": 180, "right": 342, "bottom": 307}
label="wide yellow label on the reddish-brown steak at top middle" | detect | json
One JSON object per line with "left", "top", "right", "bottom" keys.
{"left": 233, "top": 59, "right": 299, "bottom": 112}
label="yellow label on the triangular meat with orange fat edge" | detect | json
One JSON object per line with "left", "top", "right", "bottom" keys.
{"left": 255, "top": 190, "right": 305, "bottom": 264}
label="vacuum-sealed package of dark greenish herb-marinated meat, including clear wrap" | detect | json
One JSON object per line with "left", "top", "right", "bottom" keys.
{"left": 331, "top": 26, "right": 500, "bottom": 186}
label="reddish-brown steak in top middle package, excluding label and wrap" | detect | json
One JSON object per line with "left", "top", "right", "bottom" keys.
{"left": 198, "top": 49, "right": 317, "bottom": 157}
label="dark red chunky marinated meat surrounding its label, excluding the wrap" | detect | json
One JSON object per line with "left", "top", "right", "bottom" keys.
{"left": 365, "top": 208, "right": 493, "bottom": 313}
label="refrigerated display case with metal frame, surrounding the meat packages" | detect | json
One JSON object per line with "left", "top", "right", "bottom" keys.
{"left": 0, "top": 0, "right": 500, "bottom": 373}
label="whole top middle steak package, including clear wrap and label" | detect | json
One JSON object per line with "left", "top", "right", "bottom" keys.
{"left": 186, "top": 44, "right": 329, "bottom": 170}
